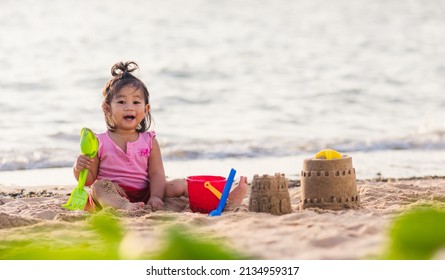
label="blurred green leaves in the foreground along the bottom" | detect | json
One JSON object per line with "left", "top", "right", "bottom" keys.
{"left": 0, "top": 203, "right": 445, "bottom": 260}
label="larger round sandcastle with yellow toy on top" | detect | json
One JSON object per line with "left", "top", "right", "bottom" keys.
{"left": 300, "top": 155, "right": 360, "bottom": 210}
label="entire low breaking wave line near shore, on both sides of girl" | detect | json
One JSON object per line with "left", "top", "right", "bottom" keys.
{"left": 0, "top": 130, "right": 445, "bottom": 171}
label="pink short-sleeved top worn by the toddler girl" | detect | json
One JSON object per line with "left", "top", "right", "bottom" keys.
{"left": 96, "top": 131, "right": 156, "bottom": 190}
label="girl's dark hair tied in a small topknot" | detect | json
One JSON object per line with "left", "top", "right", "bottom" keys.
{"left": 102, "top": 61, "right": 152, "bottom": 132}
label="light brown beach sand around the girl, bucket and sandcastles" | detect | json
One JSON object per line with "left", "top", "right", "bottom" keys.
{"left": 0, "top": 177, "right": 445, "bottom": 260}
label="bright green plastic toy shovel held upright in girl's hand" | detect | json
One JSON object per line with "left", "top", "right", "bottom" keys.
{"left": 62, "top": 127, "right": 99, "bottom": 210}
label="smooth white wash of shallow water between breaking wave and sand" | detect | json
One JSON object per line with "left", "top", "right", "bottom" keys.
{"left": 0, "top": 150, "right": 445, "bottom": 187}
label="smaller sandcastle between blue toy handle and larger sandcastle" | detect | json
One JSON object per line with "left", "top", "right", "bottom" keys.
{"left": 249, "top": 173, "right": 292, "bottom": 215}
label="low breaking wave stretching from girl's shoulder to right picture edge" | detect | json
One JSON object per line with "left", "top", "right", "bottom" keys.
{"left": 163, "top": 130, "right": 445, "bottom": 160}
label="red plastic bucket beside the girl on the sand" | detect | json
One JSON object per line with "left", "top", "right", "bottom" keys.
{"left": 187, "top": 175, "right": 226, "bottom": 214}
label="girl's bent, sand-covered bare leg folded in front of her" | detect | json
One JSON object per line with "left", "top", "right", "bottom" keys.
{"left": 91, "top": 180, "right": 145, "bottom": 210}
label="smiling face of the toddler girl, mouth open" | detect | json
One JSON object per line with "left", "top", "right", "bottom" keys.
{"left": 105, "top": 86, "right": 150, "bottom": 131}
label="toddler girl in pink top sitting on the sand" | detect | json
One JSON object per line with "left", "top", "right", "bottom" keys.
{"left": 73, "top": 61, "right": 247, "bottom": 211}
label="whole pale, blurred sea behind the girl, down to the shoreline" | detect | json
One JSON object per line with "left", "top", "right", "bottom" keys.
{"left": 0, "top": 0, "right": 445, "bottom": 184}
